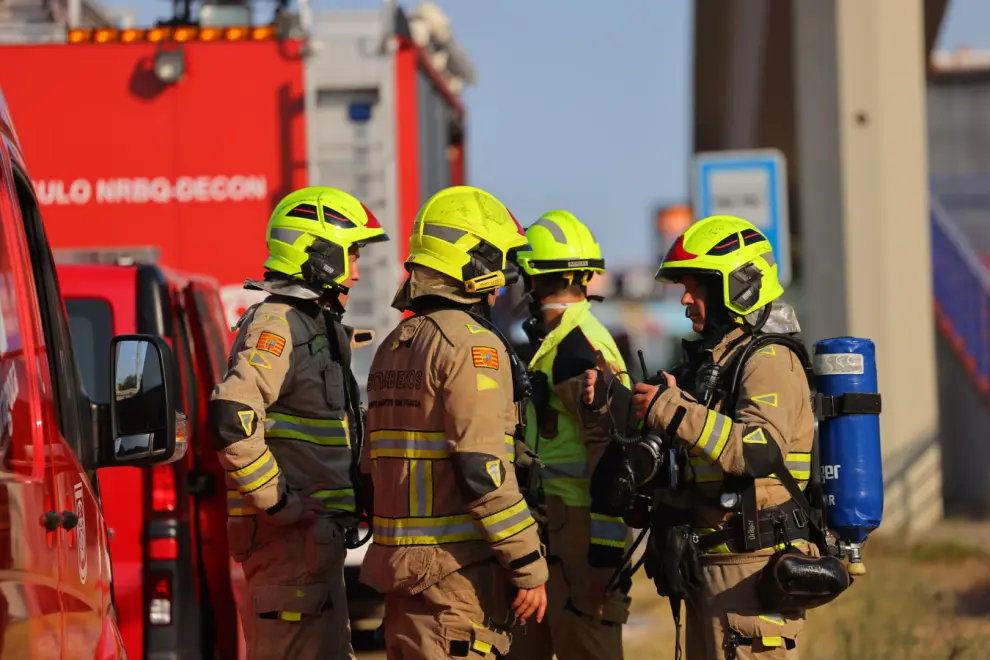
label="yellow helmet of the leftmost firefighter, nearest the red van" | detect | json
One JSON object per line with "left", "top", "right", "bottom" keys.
{"left": 265, "top": 186, "right": 389, "bottom": 293}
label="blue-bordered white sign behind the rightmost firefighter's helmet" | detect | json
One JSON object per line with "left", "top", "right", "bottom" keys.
{"left": 691, "top": 149, "right": 791, "bottom": 286}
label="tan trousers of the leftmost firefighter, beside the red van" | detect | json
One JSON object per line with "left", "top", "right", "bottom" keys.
{"left": 228, "top": 516, "right": 354, "bottom": 660}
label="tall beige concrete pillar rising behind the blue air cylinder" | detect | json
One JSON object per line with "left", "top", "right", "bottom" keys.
{"left": 794, "top": 0, "right": 942, "bottom": 533}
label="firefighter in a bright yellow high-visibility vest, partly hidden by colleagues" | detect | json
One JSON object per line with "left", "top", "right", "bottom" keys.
{"left": 511, "top": 210, "right": 631, "bottom": 660}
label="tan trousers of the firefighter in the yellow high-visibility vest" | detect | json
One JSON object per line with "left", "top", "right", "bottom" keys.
{"left": 509, "top": 497, "right": 629, "bottom": 660}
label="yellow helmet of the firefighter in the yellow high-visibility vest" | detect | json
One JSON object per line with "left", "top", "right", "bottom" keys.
{"left": 516, "top": 210, "right": 605, "bottom": 284}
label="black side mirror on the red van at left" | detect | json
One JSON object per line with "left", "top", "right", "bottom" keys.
{"left": 101, "top": 335, "right": 186, "bottom": 467}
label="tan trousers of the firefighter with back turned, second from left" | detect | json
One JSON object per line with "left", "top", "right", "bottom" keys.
{"left": 384, "top": 560, "right": 516, "bottom": 660}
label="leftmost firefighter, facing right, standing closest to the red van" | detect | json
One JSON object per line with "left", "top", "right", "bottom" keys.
{"left": 210, "top": 187, "right": 388, "bottom": 660}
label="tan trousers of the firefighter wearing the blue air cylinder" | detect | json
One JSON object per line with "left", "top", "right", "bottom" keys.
{"left": 685, "top": 554, "right": 805, "bottom": 660}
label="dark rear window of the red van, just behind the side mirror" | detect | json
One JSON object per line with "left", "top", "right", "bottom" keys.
{"left": 65, "top": 298, "right": 113, "bottom": 403}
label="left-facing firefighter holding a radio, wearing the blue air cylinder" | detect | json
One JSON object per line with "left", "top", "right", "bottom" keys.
{"left": 586, "top": 216, "right": 818, "bottom": 660}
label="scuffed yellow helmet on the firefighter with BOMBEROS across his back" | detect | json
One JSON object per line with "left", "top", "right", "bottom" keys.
{"left": 406, "top": 186, "right": 526, "bottom": 294}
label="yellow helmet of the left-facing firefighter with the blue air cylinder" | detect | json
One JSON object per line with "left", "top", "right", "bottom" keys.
{"left": 656, "top": 215, "right": 784, "bottom": 316}
